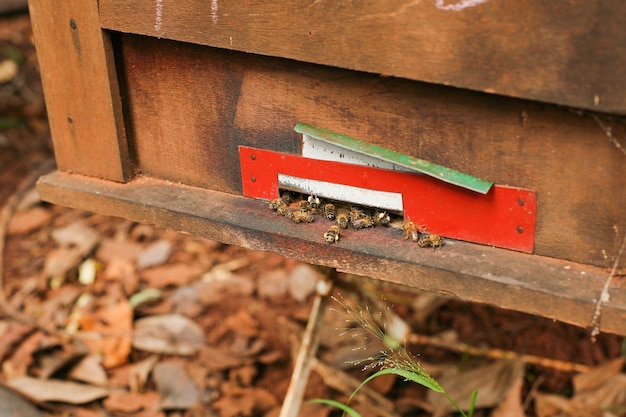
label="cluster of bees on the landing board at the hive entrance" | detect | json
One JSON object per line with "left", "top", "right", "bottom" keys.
{"left": 269, "top": 191, "right": 445, "bottom": 248}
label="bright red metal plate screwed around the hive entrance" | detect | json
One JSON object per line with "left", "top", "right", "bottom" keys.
{"left": 239, "top": 146, "right": 537, "bottom": 252}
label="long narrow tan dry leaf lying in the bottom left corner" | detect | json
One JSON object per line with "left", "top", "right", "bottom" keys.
{"left": 7, "top": 376, "right": 109, "bottom": 404}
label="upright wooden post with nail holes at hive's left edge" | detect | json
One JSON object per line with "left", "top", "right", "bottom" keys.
{"left": 29, "top": 0, "right": 131, "bottom": 181}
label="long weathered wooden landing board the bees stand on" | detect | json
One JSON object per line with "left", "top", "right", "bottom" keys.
{"left": 38, "top": 172, "right": 626, "bottom": 335}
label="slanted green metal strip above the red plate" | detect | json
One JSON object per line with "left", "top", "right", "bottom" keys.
{"left": 294, "top": 123, "right": 493, "bottom": 194}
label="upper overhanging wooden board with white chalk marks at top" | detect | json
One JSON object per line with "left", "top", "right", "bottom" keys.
{"left": 100, "top": 0, "right": 626, "bottom": 114}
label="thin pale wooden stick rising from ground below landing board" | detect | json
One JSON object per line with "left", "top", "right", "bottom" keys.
{"left": 279, "top": 271, "right": 336, "bottom": 417}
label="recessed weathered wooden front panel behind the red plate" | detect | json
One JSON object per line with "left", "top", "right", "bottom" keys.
{"left": 122, "top": 35, "right": 626, "bottom": 266}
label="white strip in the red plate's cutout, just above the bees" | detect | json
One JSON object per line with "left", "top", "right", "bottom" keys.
{"left": 278, "top": 173, "right": 404, "bottom": 212}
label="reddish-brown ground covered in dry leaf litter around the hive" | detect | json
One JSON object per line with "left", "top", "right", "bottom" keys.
{"left": 0, "top": 14, "right": 626, "bottom": 417}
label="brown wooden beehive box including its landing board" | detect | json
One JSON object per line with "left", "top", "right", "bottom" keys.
{"left": 30, "top": 0, "right": 626, "bottom": 334}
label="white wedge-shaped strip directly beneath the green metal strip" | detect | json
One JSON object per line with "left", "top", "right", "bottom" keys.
{"left": 302, "top": 135, "right": 419, "bottom": 175}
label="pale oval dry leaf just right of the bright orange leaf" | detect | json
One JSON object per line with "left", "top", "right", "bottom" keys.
{"left": 133, "top": 314, "right": 205, "bottom": 355}
